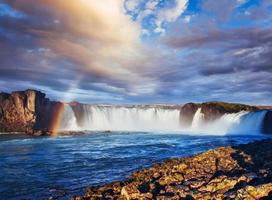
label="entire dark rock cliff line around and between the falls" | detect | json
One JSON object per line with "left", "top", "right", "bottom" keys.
{"left": 0, "top": 90, "right": 272, "bottom": 135}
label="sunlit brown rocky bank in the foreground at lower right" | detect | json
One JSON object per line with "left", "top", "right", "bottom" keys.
{"left": 72, "top": 140, "right": 272, "bottom": 200}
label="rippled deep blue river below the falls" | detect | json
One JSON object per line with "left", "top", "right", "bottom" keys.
{"left": 0, "top": 132, "right": 265, "bottom": 199}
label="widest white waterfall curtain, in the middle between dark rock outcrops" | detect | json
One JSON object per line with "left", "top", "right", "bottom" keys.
{"left": 77, "top": 105, "right": 181, "bottom": 131}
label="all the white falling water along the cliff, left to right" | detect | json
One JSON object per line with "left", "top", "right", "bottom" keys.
{"left": 60, "top": 105, "right": 266, "bottom": 135}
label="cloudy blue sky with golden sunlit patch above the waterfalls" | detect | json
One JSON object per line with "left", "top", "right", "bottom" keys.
{"left": 0, "top": 0, "right": 272, "bottom": 105}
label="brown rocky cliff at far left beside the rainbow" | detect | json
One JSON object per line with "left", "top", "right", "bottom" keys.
{"left": 0, "top": 90, "right": 61, "bottom": 134}
